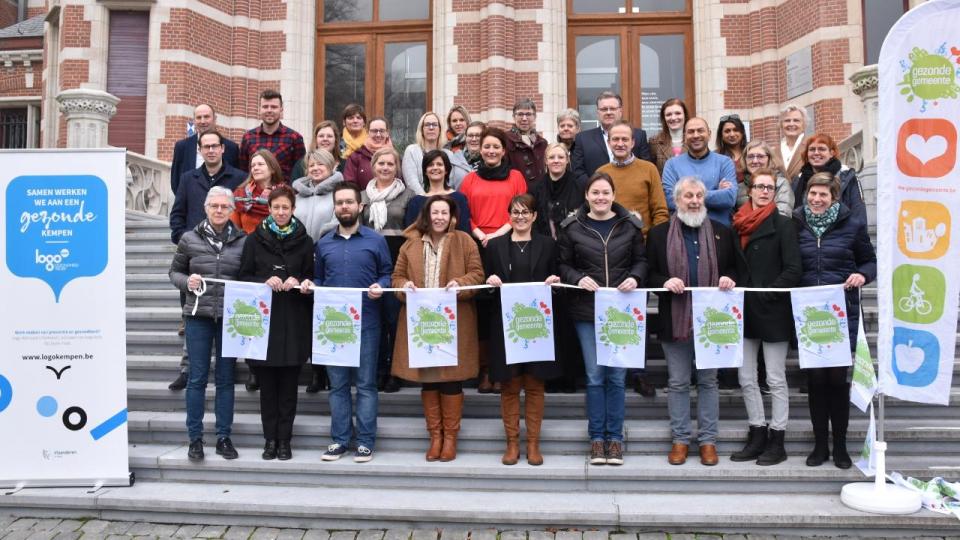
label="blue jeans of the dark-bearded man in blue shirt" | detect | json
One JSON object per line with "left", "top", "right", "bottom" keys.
{"left": 327, "top": 325, "right": 380, "bottom": 450}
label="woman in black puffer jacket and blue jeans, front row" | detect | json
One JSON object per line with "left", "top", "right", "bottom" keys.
{"left": 559, "top": 173, "right": 647, "bottom": 465}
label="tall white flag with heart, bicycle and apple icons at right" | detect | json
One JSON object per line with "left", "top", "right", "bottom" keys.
{"left": 877, "top": 0, "right": 960, "bottom": 405}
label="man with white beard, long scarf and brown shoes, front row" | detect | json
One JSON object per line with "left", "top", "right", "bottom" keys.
{"left": 647, "top": 176, "right": 746, "bottom": 465}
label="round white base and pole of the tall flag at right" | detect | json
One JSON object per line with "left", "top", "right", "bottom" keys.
{"left": 840, "top": 440, "right": 923, "bottom": 515}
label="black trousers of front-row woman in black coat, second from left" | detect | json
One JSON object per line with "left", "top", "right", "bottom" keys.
{"left": 251, "top": 362, "right": 301, "bottom": 441}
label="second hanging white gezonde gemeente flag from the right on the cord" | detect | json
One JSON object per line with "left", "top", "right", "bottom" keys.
{"left": 691, "top": 289, "right": 743, "bottom": 369}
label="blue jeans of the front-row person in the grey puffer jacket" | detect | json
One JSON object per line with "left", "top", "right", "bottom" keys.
{"left": 184, "top": 317, "right": 237, "bottom": 441}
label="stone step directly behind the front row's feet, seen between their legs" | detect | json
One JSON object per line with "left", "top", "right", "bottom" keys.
{"left": 128, "top": 410, "right": 960, "bottom": 456}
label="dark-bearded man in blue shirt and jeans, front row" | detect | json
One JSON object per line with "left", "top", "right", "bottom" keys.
{"left": 314, "top": 182, "right": 393, "bottom": 463}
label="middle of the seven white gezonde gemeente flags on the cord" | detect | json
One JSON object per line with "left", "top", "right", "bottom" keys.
{"left": 500, "top": 283, "right": 556, "bottom": 365}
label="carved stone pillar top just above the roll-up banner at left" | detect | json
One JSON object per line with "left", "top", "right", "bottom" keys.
{"left": 57, "top": 88, "right": 120, "bottom": 148}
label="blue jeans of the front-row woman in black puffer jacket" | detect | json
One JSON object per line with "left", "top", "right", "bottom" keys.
{"left": 573, "top": 321, "right": 627, "bottom": 442}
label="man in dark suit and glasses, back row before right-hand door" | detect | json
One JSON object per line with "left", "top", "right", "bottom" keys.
{"left": 570, "top": 90, "right": 655, "bottom": 183}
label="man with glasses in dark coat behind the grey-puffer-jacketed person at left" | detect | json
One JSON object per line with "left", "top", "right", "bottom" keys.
{"left": 168, "top": 129, "right": 246, "bottom": 390}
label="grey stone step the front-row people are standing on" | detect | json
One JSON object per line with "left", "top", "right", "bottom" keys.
{"left": 130, "top": 440, "right": 956, "bottom": 495}
